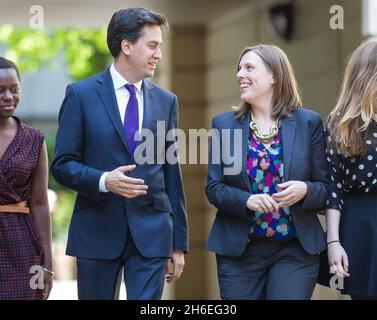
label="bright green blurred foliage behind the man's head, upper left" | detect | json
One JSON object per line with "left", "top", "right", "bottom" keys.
{"left": 0, "top": 25, "right": 111, "bottom": 80}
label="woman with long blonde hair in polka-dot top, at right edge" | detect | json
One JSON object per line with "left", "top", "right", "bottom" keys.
{"left": 326, "top": 40, "right": 377, "bottom": 299}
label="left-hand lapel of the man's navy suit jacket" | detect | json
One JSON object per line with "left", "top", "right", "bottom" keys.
{"left": 97, "top": 69, "right": 130, "bottom": 154}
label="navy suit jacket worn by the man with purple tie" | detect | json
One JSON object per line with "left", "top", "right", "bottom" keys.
{"left": 52, "top": 69, "right": 188, "bottom": 259}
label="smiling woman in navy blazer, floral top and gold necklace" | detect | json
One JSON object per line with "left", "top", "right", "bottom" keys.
{"left": 206, "top": 45, "right": 328, "bottom": 299}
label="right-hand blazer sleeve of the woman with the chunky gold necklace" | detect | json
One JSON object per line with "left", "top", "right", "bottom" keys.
{"left": 297, "top": 115, "right": 329, "bottom": 210}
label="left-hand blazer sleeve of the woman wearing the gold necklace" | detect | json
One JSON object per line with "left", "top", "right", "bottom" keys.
{"left": 205, "top": 117, "right": 251, "bottom": 218}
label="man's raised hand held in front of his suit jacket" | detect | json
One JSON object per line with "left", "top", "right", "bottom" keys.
{"left": 105, "top": 164, "right": 148, "bottom": 199}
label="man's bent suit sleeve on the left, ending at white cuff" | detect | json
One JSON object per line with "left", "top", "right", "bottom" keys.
{"left": 51, "top": 85, "right": 103, "bottom": 202}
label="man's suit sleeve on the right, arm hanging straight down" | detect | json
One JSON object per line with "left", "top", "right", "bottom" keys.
{"left": 163, "top": 96, "right": 188, "bottom": 253}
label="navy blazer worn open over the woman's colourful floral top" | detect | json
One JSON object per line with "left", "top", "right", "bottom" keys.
{"left": 206, "top": 109, "right": 328, "bottom": 256}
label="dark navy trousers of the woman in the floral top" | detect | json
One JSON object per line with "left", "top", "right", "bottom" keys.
{"left": 216, "top": 239, "right": 319, "bottom": 300}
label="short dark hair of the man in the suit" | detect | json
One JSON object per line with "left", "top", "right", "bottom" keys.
{"left": 107, "top": 8, "right": 168, "bottom": 58}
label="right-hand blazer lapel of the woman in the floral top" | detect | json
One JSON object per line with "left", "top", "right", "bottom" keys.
{"left": 281, "top": 114, "right": 296, "bottom": 180}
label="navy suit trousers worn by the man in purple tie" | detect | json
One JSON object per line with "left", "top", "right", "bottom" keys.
{"left": 77, "top": 230, "right": 166, "bottom": 300}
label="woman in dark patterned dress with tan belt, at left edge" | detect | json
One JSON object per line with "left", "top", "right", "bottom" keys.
{"left": 0, "top": 57, "right": 53, "bottom": 300}
